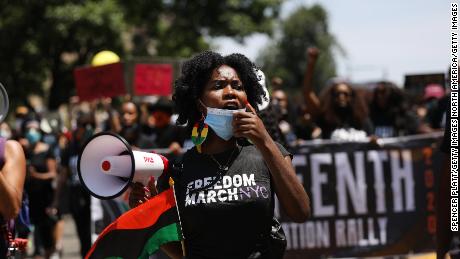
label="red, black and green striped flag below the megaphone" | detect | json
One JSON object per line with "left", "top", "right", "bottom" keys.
{"left": 85, "top": 188, "right": 181, "bottom": 259}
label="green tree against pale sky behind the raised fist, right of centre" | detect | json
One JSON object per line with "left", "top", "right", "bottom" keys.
{"left": 257, "top": 5, "right": 338, "bottom": 95}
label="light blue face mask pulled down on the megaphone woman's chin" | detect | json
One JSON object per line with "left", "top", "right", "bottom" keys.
{"left": 204, "top": 107, "right": 244, "bottom": 140}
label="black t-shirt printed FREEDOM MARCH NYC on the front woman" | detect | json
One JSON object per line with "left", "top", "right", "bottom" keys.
{"left": 171, "top": 144, "right": 290, "bottom": 258}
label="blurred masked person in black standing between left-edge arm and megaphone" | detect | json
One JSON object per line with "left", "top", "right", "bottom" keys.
{"left": 24, "top": 120, "right": 60, "bottom": 258}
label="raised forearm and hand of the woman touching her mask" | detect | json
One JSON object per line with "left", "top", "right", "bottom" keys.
{"left": 233, "top": 104, "right": 310, "bottom": 222}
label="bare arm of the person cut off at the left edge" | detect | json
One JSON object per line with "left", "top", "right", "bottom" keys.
{"left": 0, "top": 140, "right": 26, "bottom": 219}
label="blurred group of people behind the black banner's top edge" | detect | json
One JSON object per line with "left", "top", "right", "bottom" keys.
{"left": 261, "top": 78, "right": 448, "bottom": 147}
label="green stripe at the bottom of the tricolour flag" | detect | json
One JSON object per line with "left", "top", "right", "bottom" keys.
{"left": 139, "top": 223, "right": 180, "bottom": 259}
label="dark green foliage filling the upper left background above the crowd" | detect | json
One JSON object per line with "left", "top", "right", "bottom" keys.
{"left": 0, "top": 0, "right": 281, "bottom": 109}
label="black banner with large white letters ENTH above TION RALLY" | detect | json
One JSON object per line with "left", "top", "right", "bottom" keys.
{"left": 277, "top": 133, "right": 443, "bottom": 258}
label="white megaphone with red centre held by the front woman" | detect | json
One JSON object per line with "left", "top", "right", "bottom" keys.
{"left": 77, "top": 132, "right": 168, "bottom": 199}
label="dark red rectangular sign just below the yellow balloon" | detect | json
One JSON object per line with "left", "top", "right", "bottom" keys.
{"left": 74, "top": 63, "right": 126, "bottom": 101}
